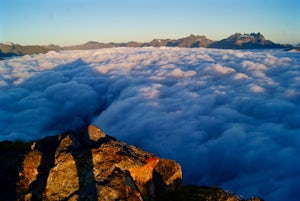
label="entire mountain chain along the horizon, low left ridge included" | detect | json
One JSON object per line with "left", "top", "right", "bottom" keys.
{"left": 0, "top": 33, "right": 293, "bottom": 58}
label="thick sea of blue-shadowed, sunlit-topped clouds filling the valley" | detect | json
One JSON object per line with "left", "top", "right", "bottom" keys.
{"left": 0, "top": 47, "right": 300, "bottom": 201}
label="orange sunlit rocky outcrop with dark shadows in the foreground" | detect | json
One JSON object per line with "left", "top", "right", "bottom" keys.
{"left": 0, "top": 125, "right": 262, "bottom": 201}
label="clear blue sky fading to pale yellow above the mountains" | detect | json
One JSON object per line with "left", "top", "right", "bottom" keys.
{"left": 0, "top": 0, "right": 300, "bottom": 45}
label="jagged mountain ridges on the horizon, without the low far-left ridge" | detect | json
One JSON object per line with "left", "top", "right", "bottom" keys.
{"left": 63, "top": 33, "right": 292, "bottom": 50}
